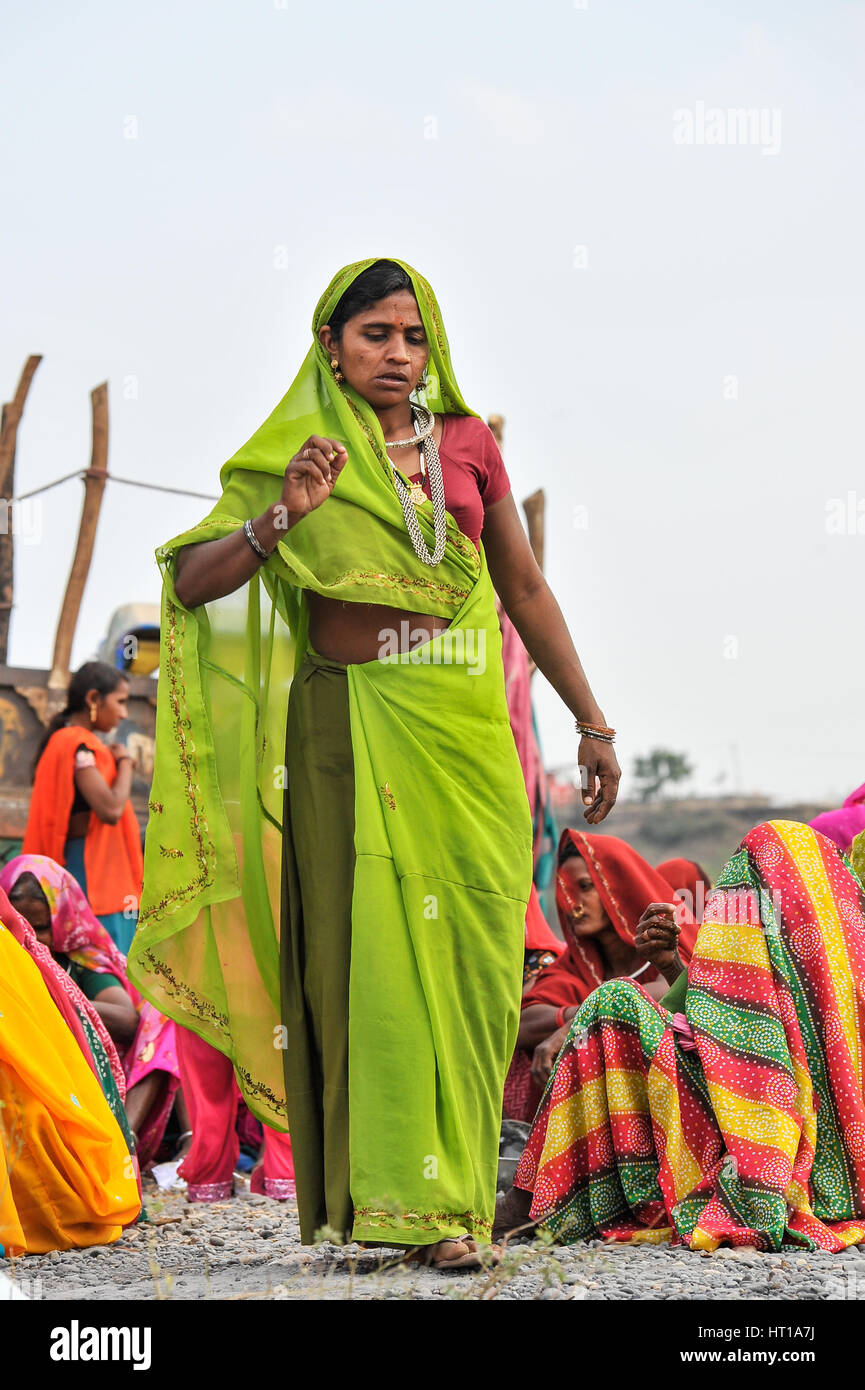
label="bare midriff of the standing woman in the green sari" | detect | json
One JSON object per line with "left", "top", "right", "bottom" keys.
{"left": 306, "top": 589, "right": 451, "bottom": 666}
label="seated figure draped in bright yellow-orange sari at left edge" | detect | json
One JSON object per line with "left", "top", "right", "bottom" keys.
{"left": 0, "top": 897, "right": 140, "bottom": 1255}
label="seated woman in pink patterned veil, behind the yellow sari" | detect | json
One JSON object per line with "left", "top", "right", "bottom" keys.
{"left": 0, "top": 855, "right": 192, "bottom": 1169}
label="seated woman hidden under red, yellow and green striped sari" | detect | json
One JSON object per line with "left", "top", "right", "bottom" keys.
{"left": 494, "top": 820, "right": 865, "bottom": 1251}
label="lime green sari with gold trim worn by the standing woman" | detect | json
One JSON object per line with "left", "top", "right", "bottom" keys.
{"left": 128, "top": 259, "right": 531, "bottom": 1243}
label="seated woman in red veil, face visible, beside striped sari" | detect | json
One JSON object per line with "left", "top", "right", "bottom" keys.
{"left": 503, "top": 830, "right": 697, "bottom": 1120}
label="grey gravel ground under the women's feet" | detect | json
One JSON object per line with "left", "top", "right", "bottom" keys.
{"left": 6, "top": 1190, "right": 865, "bottom": 1301}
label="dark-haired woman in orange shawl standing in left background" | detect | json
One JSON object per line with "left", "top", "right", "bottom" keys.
{"left": 21, "top": 662, "right": 143, "bottom": 956}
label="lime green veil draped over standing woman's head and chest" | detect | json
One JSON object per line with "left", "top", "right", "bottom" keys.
{"left": 191, "top": 257, "right": 480, "bottom": 655}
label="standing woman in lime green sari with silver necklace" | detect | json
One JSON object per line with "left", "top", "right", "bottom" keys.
{"left": 128, "top": 259, "right": 619, "bottom": 1268}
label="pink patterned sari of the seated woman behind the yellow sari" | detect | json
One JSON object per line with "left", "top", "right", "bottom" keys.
{"left": 0, "top": 855, "right": 181, "bottom": 1169}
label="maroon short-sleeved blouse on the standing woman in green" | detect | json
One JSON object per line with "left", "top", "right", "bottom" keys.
{"left": 406, "top": 416, "right": 510, "bottom": 546}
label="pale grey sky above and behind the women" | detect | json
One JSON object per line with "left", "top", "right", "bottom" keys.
{"left": 0, "top": 0, "right": 865, "bottom": 801}
